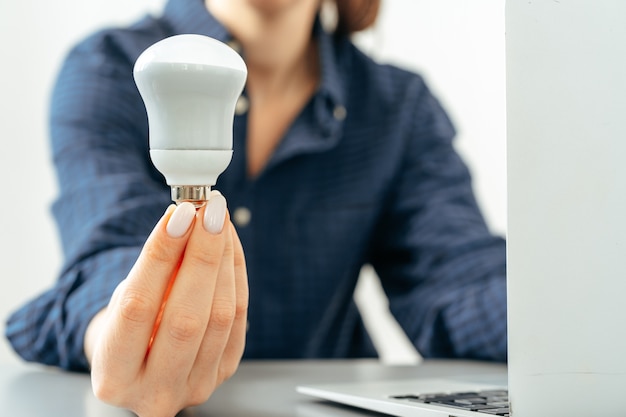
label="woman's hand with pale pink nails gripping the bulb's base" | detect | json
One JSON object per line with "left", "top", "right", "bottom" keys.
{"left": 85, "top": 192, "right": 248, "bottom": 417}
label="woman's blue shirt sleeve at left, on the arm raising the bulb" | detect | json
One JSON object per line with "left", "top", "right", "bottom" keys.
{"left": 7, "top": 32, "right": 169, "bottom": 371}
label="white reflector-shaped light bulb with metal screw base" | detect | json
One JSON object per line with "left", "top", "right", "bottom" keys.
{"left": 133, "top": 34, "right": 248, "bottom": 207}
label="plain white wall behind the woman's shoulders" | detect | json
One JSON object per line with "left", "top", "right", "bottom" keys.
{"left": 0, "top": 0, "right": 506, "bottom": 362}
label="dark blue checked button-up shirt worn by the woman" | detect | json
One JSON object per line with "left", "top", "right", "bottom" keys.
{"left": 6, "top": 0, "right": 506, "bottom": 370}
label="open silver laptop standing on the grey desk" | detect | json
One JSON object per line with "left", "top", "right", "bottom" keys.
{"left": 298, "top": 0, "right": 626, "bottom": 417}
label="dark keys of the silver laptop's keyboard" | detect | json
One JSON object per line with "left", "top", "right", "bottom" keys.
{"left": 391, "top": 390, "right": 510, "bottom": 416}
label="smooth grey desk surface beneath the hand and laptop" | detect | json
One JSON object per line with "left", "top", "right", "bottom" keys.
{"left": 0, "top": 360, "right": 506, "bottom": 417}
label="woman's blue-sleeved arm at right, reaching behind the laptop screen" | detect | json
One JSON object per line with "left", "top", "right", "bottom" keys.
{"left": 372, "top": 80, "right": 506, "bottom": 361}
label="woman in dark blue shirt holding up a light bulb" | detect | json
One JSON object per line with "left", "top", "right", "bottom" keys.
{"left": 7, "top": 0, "right": 506, "bottom": 417}
